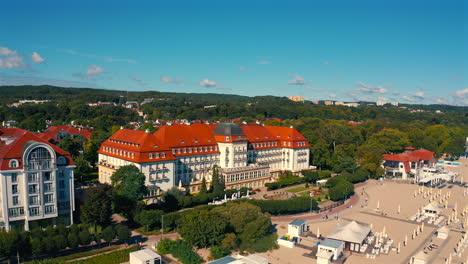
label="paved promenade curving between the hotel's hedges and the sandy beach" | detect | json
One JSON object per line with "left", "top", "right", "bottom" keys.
{"left": 271, "top": 182, "right": 367, "bottom": 222}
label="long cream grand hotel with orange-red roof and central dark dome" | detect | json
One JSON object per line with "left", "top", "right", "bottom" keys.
{"left": 98, "top": 123, "right": 310, "bottom": 201}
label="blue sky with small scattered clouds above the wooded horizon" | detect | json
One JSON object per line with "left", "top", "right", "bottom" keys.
{"left": 0, "top": 0, "right": 468, "bottom": 105}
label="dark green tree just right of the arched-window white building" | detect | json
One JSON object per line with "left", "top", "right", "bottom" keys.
{"left": 80, "top": 184, "right": 112, "bottom": 226}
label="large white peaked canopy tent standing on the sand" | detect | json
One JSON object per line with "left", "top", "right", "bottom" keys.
{"left": 327, "top": 221, "right": 371, "bottom": 244}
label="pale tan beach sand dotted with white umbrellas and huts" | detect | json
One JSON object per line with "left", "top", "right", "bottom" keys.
{"left": 260, "top": 159, "right": 468, "bottom": 264}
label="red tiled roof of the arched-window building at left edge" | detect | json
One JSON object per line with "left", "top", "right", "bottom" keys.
{"left": 0, "top": 128, "right": 74, "bottom": 170}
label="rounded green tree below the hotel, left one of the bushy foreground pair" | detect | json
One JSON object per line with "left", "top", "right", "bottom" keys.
{"left": 178, "top": 210, "right": 226, "bottom": 248}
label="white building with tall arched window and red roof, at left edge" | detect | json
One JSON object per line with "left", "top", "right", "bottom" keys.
{"left": 0, "top": 128, "right": 75, "bottom": 231}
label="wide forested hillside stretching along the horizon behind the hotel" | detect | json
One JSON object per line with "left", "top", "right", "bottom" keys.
{"left": 0, "top": 86, "right": 468, "bottom": 175}
